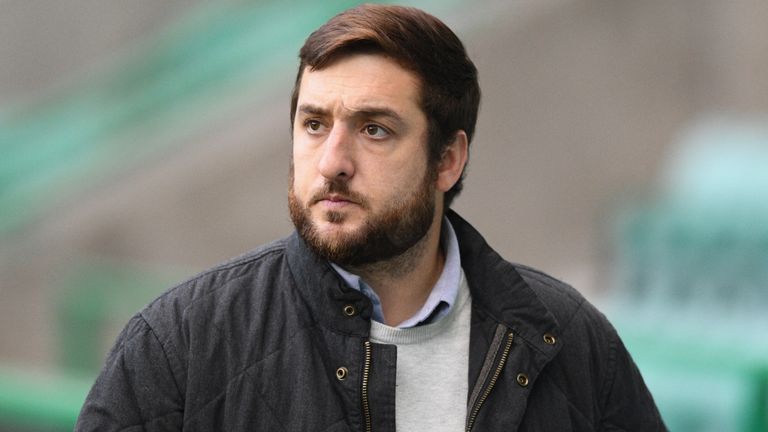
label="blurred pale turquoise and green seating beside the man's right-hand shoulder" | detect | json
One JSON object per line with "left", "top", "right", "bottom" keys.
{"left": 609, "top": 118, "right": 768, "bottom": 432}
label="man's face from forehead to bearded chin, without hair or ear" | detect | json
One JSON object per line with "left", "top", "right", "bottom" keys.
{"left": 289, "top": 54, "right": 435, "bottom": 266}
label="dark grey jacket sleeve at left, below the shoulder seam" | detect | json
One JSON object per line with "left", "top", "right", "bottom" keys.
{"left": 75, "top": 315, "right": 184, "bottom": 432}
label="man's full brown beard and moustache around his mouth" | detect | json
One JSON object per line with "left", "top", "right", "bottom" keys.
{"left": 288, "top": 166, "right": 436, "bottom": 267}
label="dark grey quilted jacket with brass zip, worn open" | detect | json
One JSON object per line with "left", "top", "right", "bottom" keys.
{"left": 75, "top": 211, "right": 665, "bottom": 432}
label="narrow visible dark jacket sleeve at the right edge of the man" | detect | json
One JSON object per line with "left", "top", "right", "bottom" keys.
{"left": 600, "top": 325, "right": 667, "bottom": 432}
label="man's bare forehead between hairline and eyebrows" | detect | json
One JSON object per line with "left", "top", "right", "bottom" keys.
{"left": 298, "top": 54, "right": 421, "bottom": 115}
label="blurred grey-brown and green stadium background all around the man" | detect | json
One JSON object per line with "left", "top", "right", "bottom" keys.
{"left": 0, "top": 0, "right": 768, "bottom": 431}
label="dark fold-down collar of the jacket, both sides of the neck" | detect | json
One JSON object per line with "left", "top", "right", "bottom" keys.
{"left": 287, "top": 210, "right": 560, "bottom": 354}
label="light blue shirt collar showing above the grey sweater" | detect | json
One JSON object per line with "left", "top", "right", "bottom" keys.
{"left": 331, "top": 218, "right": 461, "bottom": 328}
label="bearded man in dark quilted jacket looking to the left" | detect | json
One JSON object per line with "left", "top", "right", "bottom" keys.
{"left": 76, "top": 6, "right": 664, "bottom": 431}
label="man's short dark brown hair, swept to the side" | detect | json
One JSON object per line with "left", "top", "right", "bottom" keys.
{"left": 291, "top": 5, "right": 480, "bottom": 209}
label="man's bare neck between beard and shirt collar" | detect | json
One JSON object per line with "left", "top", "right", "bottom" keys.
{"left": 348, "top": 212, "right": 445, "bottom": 326}
